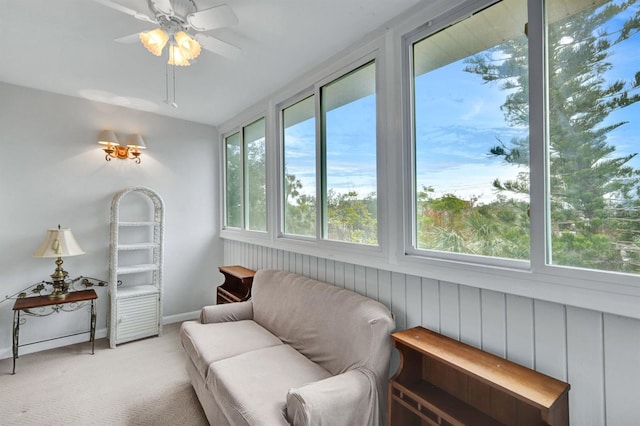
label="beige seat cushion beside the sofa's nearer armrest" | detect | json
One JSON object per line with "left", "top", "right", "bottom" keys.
{"left": 207, "top": 345, "right": 331, "bottom": 426}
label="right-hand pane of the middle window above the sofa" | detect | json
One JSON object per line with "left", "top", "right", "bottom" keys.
{"left": 321, "top": 63, "right": 378, "bottom": 244}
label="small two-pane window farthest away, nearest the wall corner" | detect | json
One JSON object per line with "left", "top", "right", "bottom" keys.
{"left": 225, "top": 118, "right": 267, "bottom": 231}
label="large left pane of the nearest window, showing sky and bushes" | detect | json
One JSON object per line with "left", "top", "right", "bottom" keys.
{"left": 413, "top": 0, "right": 530, "bottom": 259}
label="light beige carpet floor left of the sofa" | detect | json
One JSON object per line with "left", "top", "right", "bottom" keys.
{"left": 0, "top": 324, "right": 208, "bottom": 426}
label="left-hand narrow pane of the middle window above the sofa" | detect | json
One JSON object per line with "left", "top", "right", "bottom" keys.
{"left": 282, "top": 96, "right": 316, "bottom": 237}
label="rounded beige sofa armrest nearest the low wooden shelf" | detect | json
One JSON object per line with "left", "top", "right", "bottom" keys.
{"left": 287, "top": 368, "right": 381, "bottom": 426}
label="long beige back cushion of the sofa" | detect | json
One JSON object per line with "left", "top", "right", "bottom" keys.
{"left": 251, "top": 270, "right": 395, "bottom": 380}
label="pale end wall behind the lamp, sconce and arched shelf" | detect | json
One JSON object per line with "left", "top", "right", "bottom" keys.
{"left": 0, "top": 83, "right": 223, "bottom": 360}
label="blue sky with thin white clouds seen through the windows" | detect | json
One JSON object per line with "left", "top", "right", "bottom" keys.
{"left": 286, "top": 0, "right": 640, "bottom": 203}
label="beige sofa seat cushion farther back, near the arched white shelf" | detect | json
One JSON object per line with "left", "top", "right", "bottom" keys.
{"left": 180, "top": 320, "right": 282, "bottom": 380}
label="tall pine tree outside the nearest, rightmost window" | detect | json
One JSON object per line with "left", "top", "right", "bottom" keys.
{"left": 465, "top": 0, "right": 640, "bottom": 271}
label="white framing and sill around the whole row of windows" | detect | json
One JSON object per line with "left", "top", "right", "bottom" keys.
{"left": 219, "top": 0, "right": 640, "bottom": 319}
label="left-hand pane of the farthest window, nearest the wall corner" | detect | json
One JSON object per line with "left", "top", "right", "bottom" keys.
{"left": 225, "top": 133, "right": 242, "bottom": 228}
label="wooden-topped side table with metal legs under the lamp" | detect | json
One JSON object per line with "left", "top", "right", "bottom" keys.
{"left": 11, "top": 290, "right": 98, "bottom": 374}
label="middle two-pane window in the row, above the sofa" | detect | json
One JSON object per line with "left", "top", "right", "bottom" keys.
{"left": 281, "top": 62, "right": 378, "bottom": 245}
